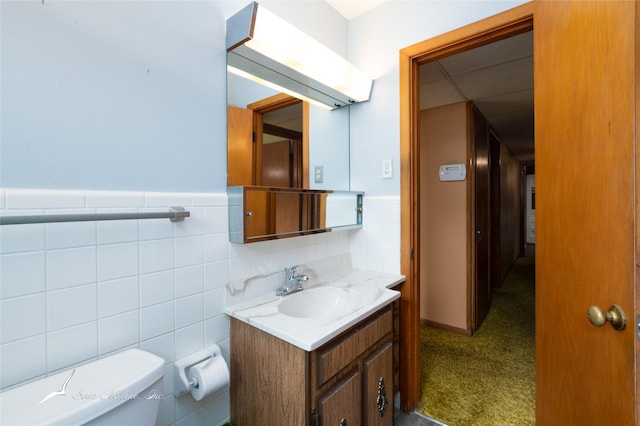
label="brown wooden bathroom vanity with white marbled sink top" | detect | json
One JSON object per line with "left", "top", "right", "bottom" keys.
{"left": 227, "top": 270, "right": 404, "bottom": 426}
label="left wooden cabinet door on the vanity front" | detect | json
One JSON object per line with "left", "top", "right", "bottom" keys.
{"left": 318, "top": 370, "right": 364, "bottom": 426}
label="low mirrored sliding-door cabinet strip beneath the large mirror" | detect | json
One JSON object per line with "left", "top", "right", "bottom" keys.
{"left": 227, "top": 186, "right": 363, "bottom": 243}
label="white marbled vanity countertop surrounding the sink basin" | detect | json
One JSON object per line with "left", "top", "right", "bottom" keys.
{"left": 225, "top": 269, "right": 405, "bottom": 351}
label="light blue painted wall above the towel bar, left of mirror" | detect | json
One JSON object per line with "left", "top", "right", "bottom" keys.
{"left": 0, "top": 0, "right": 347, "bottom": 192}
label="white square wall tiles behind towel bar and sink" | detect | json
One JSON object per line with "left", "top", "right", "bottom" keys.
{"left": 0, "top": 189, "right": 399, "bottom": 425}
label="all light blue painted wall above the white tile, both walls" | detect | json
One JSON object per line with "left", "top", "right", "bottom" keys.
{"left": 0, "top": 0, "right": 524, "bottom": 196}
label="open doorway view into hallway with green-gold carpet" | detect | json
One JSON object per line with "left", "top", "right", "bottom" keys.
{"left": 419, "top": 31, "right": 535, "bottom": 424}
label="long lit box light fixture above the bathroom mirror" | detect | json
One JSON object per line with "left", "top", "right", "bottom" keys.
{"left": 226, "top": 2, "right": 373, "bottom": 109}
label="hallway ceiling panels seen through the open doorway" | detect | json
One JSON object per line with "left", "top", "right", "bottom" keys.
{"left": 420, "top": 32, "right": 534, "bottom": 160}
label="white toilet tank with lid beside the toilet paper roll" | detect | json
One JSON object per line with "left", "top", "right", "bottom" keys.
{"left": 0, "top": 349, "right": 165, "bottom": 426}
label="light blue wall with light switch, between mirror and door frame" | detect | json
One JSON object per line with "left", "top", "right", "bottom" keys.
{"left": 349, "top": 0, "right": 526, "bottom": 196}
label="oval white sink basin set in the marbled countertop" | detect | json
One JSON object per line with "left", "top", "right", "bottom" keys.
{"left": 278, "top": 287, "right": 353, "bottom": 318}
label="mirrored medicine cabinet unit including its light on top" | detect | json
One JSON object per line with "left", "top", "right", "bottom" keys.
{"left": 226, "top": 3, "right": 372, "bottom": 243}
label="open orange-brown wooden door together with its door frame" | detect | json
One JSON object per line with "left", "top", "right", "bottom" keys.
{"left": 400, "top": 0, "right": 640, "bottom": 425}
